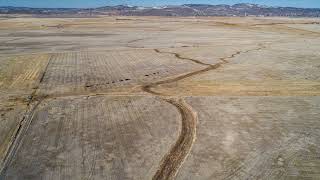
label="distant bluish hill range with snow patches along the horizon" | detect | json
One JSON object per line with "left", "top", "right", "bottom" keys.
{"left": 0, "top": 3, "right": 320, "bottom": 17}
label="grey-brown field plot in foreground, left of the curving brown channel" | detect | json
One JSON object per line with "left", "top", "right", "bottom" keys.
{"left": 0, "top": 96, "right": 181, "bottom": 179}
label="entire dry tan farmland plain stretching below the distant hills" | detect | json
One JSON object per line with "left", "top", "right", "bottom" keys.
{"left": 0, "top": 16, "right": 320, "bottom": 180}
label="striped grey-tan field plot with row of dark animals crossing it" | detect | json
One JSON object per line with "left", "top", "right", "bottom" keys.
{"left": 41, "top": 50, "right": 202, "bottom": 93}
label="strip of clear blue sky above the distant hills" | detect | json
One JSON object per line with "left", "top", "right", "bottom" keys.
{"left": 0, "top": 0, "right": 320, "bottom": 8}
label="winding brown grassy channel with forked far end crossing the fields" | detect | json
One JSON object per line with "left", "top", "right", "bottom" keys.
{"left": 142, "top": 44, "right": 266, "bottom": 180}
